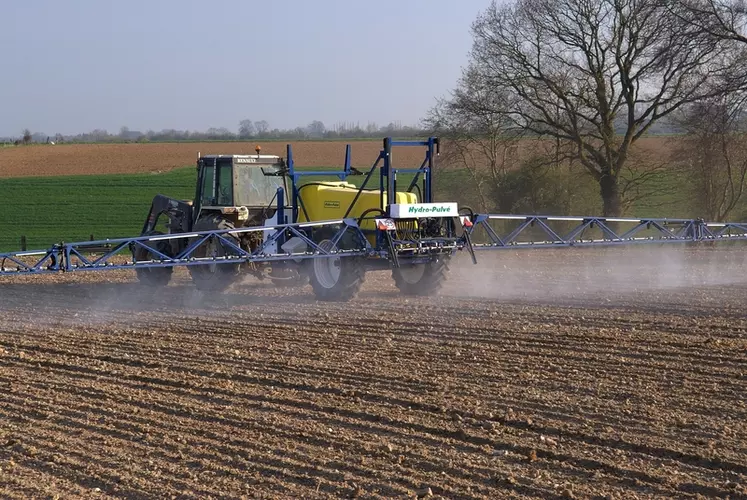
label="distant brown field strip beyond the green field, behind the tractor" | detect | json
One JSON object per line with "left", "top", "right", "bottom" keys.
{"left": 0, "top": 141, "right": 424, "bottom": 177}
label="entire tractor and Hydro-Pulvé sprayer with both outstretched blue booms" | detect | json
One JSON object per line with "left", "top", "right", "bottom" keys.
{"left": 0, "top": 137, "right": 747, "bottom": 300}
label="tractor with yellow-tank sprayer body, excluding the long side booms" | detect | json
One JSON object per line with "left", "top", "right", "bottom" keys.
{"left": 131, "top": 138, "right": 474, "bottom": 300}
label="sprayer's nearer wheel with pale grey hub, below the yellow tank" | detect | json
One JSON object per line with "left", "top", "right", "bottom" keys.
{"left": 308, "top": 239, "right": 366, "bottom": 302}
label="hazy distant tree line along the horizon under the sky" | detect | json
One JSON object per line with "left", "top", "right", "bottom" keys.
{"left": 0, "top": 119, "right": 429, "bottom": 144}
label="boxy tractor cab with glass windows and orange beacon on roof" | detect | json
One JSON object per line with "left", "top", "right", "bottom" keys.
{"left": 193, "top": 148, "right": 288, "bottom": 225}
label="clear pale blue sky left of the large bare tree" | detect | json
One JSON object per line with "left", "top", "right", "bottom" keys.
{"left": 0, "top": 0, "right": 490, "bottom": 136}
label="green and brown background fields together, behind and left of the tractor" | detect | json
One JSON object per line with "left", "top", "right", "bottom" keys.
{"left": 0, "top": 140, "right": 423, "bottom": 251}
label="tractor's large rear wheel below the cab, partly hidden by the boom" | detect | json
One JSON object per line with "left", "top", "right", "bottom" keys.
{"left": 189, "top": 215, "right": 239, "bottom": 293}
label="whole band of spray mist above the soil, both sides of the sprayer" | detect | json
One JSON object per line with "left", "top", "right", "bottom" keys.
{"left": 0, "top": 244, "right": 747, "bottom": 331}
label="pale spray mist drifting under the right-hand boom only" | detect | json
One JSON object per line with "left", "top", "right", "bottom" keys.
{"left": 444, "top": 245, "right": 747, "bottom": 302}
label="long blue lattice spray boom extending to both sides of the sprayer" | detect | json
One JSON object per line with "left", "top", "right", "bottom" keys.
{"left": 5, "top": 214, "right": 747, "bottom": 275}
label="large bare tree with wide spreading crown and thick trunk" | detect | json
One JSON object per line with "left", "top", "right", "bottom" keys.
{"left": 462, "top": 0, "right": 744, "bottom": 216}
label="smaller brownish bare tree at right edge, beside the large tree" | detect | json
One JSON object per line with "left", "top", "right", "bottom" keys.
{"left": 675, "top": 94, "right": 747, "bottom": 221}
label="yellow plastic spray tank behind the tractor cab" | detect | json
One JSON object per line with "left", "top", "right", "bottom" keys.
{"left": 298, "top": 181, "right": 418, "bottom": 245}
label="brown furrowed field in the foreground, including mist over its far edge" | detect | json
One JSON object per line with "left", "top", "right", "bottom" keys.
{"left": 0, "top": 249, "right": 747, "bottom": 499}
